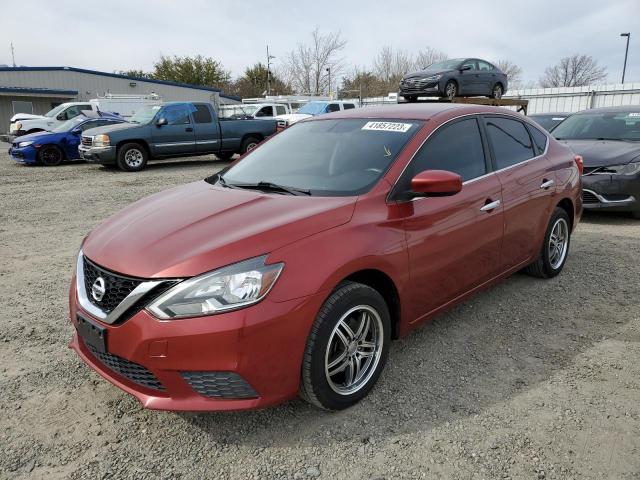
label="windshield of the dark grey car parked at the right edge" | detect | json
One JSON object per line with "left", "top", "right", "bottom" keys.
{"left": 552, "top": 109, "right": 640, "bottom": 141}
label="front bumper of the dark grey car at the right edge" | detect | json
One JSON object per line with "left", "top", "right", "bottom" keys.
{"left": 582, "top": 175, "right": 640, "bottom": 212}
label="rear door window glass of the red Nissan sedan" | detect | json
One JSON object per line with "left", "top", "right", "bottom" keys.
{"left": 486, "top": 117, "right": 535, "bottom": 170}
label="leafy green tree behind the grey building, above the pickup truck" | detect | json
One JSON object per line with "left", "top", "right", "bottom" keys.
{"left": 152, "top": 55, "right": 231, "bottom": 88}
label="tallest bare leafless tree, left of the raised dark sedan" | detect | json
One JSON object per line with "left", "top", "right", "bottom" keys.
{"left": 284, "top": 28, "right": 347, "bottom": 95}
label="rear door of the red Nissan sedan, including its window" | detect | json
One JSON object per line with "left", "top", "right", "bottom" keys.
{"left": 484, "top": 116, "right": 555, "bottom": 270}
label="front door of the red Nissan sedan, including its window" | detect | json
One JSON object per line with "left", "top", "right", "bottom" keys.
{"left": 396, "top": 117, "right": 503, "bottom": 320}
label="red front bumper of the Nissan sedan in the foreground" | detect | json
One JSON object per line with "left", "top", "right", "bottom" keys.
{"left": 69, "top": 278, "right": 324, "bottom": 411}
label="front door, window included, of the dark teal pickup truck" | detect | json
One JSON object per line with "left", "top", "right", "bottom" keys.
{"left": 151, "top": 103, "right": 196, "bottom": 156}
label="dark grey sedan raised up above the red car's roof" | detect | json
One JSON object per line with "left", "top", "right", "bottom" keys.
{"left": 400, "top": 58, "right": 507, "bottom": 102}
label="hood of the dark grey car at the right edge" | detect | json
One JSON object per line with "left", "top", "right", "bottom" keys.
{"left": 560, "top": 140, "right": 640, "bottom": 167}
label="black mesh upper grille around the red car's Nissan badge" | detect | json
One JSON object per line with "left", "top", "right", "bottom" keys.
{"left": 83, "top": 257, "right": 143, "bottom": 313}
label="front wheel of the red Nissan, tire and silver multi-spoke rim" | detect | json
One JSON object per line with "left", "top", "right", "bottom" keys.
{"left": 299, "top": 282, "right": 391, "bottom": 410}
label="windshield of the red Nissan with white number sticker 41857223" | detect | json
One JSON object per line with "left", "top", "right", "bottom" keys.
{"left": 222, "top": 118, "right": 422, "bottom": 196}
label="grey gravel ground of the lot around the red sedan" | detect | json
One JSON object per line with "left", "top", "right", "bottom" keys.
{"left": 0, "top": 153, "right": 640, "bottom": 479}
